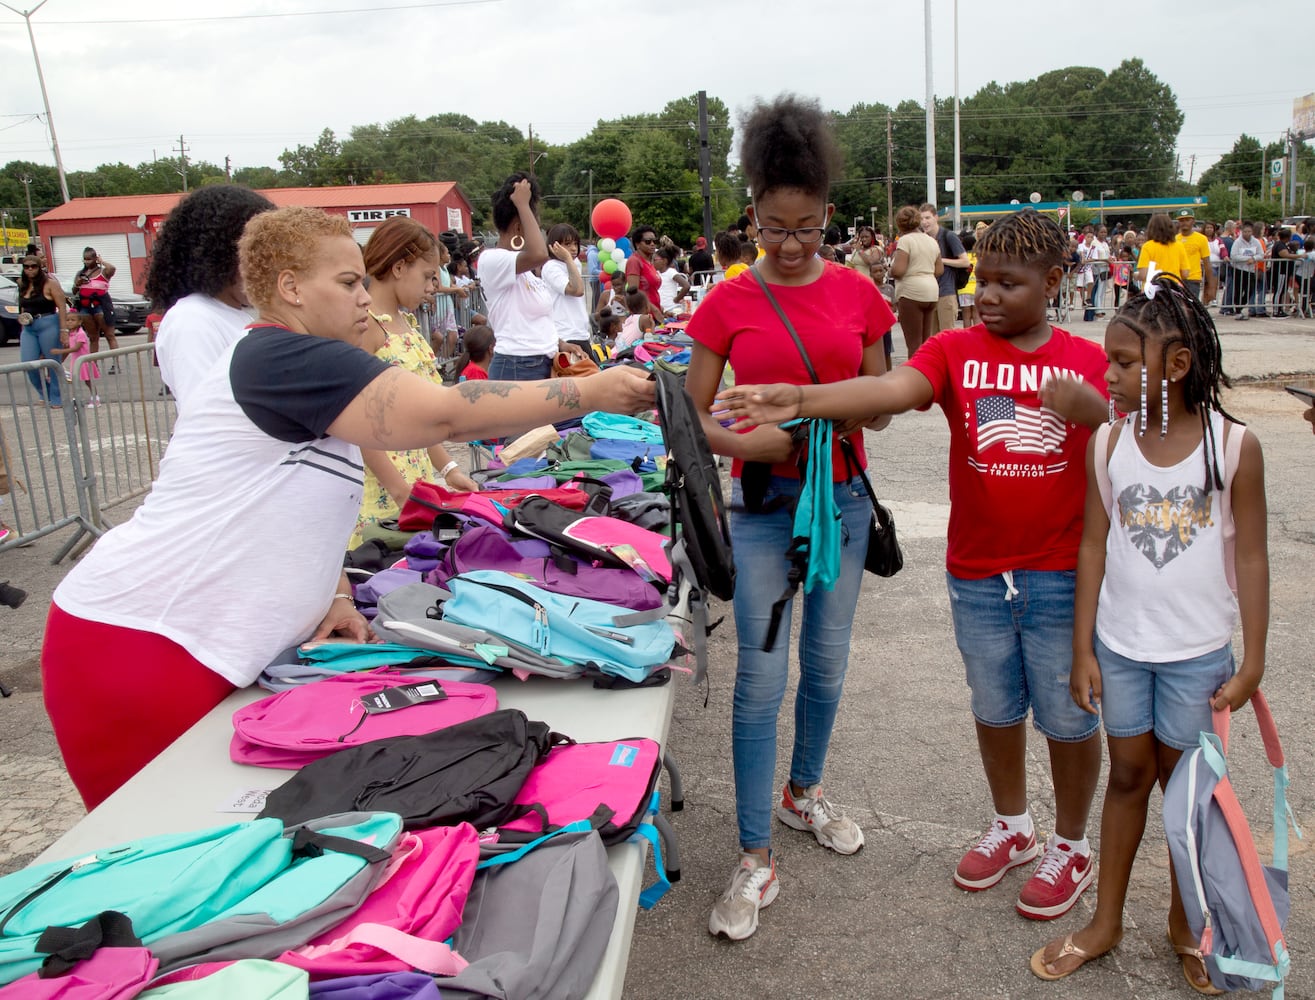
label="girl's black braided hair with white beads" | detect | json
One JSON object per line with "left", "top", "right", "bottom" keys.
{"left": 1114, "top": 274, "right": 1243, "bottom": 493}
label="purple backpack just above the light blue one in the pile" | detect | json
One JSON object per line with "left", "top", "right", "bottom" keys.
{"left": 426, "top": 525, "right": 663, "bottom": 611}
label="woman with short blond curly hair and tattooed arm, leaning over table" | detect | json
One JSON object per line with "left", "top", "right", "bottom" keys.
{"left": 41, "top": 208, "right": 654, "bottom": 808}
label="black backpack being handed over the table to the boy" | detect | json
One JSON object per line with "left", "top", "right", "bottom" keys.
{"left": 617, "top": 366, "right": 735, "bottom": 682}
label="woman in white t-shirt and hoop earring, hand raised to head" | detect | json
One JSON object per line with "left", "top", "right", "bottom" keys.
{"left": 480, "top": 171, "right": 585, "bottom": 382}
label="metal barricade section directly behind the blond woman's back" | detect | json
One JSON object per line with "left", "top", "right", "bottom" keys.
{"left": 66, "top": 343, "right": 178, "bottom": 525}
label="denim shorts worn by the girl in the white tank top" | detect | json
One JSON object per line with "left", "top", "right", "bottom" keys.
{"left": 1095, "top": 638, "right": 1233, "bottom": 750}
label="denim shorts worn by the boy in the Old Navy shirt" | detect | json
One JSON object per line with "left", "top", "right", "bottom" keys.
{"left": 945, "top": 570, "right": 1101, "bottom": 743}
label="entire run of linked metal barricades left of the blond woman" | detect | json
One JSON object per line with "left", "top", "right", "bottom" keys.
{"left": 0, "top": 343, "right": 175, "bottom": 563}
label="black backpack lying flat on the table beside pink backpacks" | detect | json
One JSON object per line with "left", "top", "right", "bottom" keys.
{"left": 260, "top": 708, "right": 565, "bottom": 830}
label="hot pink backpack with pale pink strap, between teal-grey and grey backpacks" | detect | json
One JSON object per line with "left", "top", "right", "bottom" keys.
{"left": 279, "top": 822, "right": 480, "bottom": 978}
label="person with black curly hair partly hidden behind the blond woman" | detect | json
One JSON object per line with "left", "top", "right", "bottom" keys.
{"left": 146, "top": 184, "right": 274, "bottom": 409}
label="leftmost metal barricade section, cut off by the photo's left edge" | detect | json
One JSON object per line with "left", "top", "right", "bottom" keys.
{"left": 0, "top": 359, "right": 104, "bottom": 563}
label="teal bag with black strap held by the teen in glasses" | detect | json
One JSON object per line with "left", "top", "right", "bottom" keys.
{"left": 763, "top": 420, "right": 842, "bottom": 653}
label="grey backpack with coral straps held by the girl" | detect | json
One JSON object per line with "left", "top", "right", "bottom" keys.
{"left": 1164, "top": 691, "right": 1302, "bottom": 1000}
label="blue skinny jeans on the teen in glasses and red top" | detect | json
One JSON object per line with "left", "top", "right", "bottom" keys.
{"left": 730, "top": 476, "right": 872, "bottom": 850}
